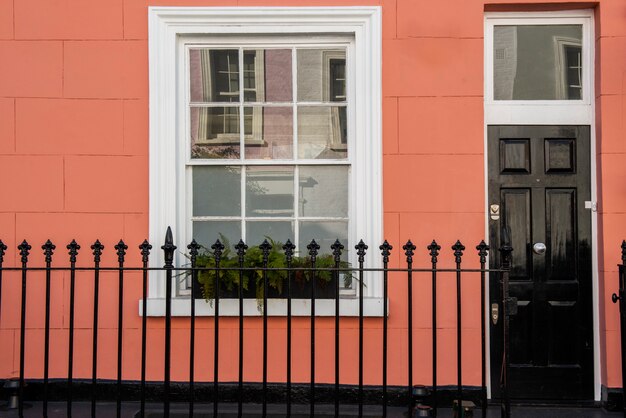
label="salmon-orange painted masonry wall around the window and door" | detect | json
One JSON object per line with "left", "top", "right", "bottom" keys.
{"left": 0, "top": 0, "right": 626, "bottom": 396}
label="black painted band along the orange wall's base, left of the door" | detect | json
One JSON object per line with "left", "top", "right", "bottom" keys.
{"left": 2, "top": 380, "right": 482, "bottom": 407}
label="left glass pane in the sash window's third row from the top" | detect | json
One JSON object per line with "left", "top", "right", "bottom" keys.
{"left": 193, "top": 166, "right": 241, "bottom": 216}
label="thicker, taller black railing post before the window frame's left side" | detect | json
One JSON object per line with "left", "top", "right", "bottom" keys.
{"left": 161, "top": 226, "right": 176, "bottom": 418}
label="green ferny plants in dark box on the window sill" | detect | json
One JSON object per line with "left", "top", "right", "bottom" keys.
{"left": 191, "top": 235, "right": 353, "bottom": 310}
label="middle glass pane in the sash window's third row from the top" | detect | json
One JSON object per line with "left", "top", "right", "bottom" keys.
{"left": 246, "top": 166, "right": 293, "bottom": 217}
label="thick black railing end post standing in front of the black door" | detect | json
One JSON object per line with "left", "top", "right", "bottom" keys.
{"left": 500, "top": 237, "right": 513, "bottom": 418}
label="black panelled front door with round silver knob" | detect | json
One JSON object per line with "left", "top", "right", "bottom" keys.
{"left": 488, "top": 126, "right": 593, "bottom": 400}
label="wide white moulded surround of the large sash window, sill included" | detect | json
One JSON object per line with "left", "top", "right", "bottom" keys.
{"left": 146, "top": 7, "right": 383, "bottom": 316}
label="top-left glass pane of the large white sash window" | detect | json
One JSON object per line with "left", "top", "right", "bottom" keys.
{"left": 189, "top": 49, "right": 239, "bottom": 102}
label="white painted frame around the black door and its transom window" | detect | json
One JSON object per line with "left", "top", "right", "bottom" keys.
{"left": 483, "top": 10, "right": 601, "bottom": 401}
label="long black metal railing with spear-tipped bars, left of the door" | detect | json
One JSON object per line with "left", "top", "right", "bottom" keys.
{"left": 0, "top": 228, "right": 512, "bottom": 417}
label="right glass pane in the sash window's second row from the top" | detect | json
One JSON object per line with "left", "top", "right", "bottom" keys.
{"left": 298, "top": 106, "right": 348, "bottom": 159}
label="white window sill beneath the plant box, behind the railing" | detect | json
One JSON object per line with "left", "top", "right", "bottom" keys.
{"left": 139, "top": 297, "right": 383, "bottom": 317}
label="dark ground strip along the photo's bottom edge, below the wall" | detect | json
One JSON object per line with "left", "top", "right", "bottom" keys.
{"left": 0, "top": 402, "right": 623, "bottom": 418}
